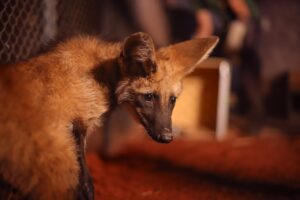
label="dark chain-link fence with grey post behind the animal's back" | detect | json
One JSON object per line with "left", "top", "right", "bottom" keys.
{"left": 0, "top": 0, "right": 100, "bottom": 64}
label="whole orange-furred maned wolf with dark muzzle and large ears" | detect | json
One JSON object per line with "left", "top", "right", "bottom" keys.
{"left": 0, "top": 33, "right": 218, "bottom": 200}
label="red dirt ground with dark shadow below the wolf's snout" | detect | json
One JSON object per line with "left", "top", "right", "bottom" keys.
{"left": 88, "top": 135, "right": 300, "bottom": 200}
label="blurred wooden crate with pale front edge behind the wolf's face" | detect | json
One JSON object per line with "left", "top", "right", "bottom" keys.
{"left": 173, "top": 58, "right": 230, "bottom": 139}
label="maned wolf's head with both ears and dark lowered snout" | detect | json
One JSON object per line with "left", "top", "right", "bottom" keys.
{"left": 116, "top": 33, "right": 218, "bottom": 143}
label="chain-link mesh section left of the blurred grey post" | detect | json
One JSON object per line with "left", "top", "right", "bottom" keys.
{"left": 0, "top": 0, "right": 44, "bottom": 63}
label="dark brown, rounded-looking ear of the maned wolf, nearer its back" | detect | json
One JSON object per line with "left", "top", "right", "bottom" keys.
{"left": 120, "top": 32, "right": 156, "bottom": 77}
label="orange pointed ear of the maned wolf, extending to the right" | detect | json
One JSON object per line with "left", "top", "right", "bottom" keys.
{"left": 158, "top": 36, "right": 219, "bottom": 78}
